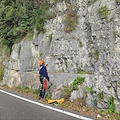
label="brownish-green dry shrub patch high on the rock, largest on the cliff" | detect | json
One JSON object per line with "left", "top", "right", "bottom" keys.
{"left": 64, "top": 7, "right": 78, "bottom": 33}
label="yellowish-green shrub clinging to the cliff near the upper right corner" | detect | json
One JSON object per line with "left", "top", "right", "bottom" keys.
{"left": 98, "top": 5, "right": 109, "bottom": 20}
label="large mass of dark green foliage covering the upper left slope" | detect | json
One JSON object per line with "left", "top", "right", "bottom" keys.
{"left": 0, "top": 0, "right": 53, "bottom": 53}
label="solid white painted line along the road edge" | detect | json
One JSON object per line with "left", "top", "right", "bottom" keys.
{"left": 0, "top": 89, "right": 93, "bottom": 120}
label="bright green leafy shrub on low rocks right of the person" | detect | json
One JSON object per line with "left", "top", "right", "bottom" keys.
{"left": 71, "top": 76, "right": 85, "bottom": 90}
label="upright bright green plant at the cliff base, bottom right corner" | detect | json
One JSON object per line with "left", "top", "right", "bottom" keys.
{"left": 107, "top": 97, "right": 115, "bottom": 113}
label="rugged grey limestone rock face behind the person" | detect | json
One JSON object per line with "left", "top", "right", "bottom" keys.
{"left": 3, "top": 0, "right": 120, "bottom": 111}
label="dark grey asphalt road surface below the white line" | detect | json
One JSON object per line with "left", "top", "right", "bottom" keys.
{"left": 0, "top": 91, "right": 94, "bottom": 120}
